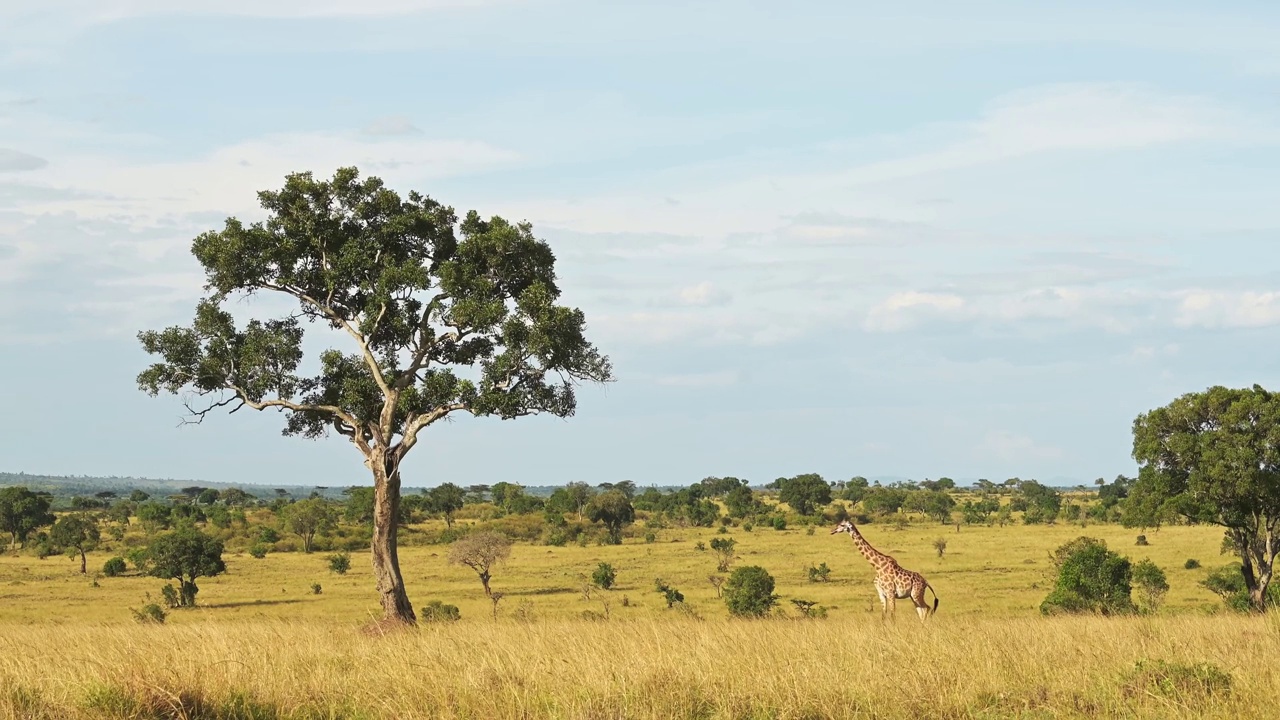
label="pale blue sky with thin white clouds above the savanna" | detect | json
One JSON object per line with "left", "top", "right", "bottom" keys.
{"left": 0, "top": 0, "right": 1280, "bottom": 486}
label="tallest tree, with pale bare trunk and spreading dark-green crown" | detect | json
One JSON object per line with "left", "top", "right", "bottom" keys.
{"left": 138, "top": 168, "right": 612, "bottom": 623}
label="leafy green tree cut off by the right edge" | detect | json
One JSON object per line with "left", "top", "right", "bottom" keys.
{"left": 1124, "top": 386, "right": 1280, "bottom": 611}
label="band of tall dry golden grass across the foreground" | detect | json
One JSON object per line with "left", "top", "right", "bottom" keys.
{"left": 0, "top": 615, "right": 1280, "bottom": 719}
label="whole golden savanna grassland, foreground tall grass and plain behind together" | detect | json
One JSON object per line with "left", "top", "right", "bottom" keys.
{"left": 0, "top": 512, "right": 1280, "bottom": 719}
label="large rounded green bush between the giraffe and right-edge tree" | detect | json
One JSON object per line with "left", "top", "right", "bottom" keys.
{"left": 1041, "top": 537, "right": 1134, "bottom": 615}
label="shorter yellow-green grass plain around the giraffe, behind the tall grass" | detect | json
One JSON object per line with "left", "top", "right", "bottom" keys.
{"left": 0, "top": 523, "right": 1233, "bottom": 625}
